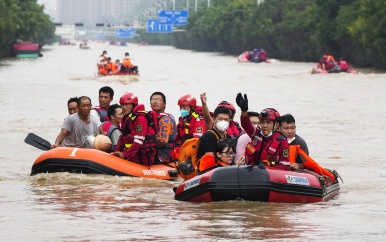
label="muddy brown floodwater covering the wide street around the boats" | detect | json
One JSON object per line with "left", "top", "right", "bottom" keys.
{"left": 0, "top": 42, "right": 386, "bottom": 241}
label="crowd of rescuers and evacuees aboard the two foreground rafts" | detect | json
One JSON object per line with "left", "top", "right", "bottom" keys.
{"left": 52, "top": 86, "right": 314, "bottom": 179}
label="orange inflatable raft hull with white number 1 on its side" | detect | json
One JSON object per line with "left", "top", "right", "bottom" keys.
{"left": 31, "top": 147, "right": 178, "bottom": 180}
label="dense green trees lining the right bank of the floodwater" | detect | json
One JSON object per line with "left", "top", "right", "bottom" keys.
{"left": 165, "top": 0, "right": 386, "bottom": 69}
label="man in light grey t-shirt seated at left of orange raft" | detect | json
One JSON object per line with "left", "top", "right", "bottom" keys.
{"left": 51, "top": 96, "right": 103, "bottom": 148}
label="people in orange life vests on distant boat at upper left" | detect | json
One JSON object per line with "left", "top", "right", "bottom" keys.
{"left": 97, "top": 50, "right": 139, "bottom": 76}
